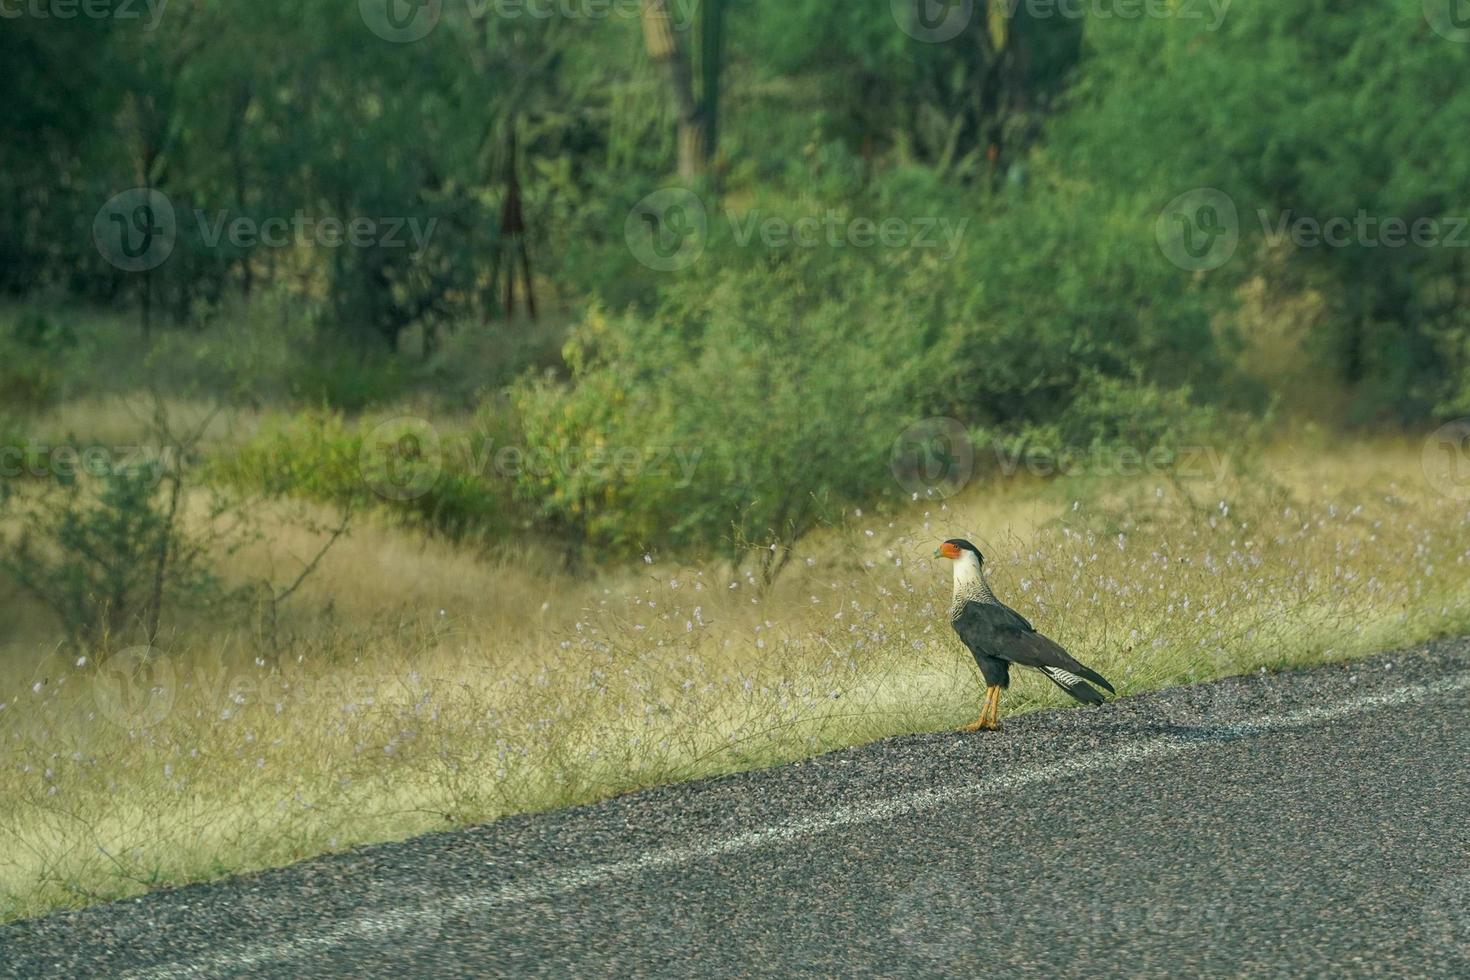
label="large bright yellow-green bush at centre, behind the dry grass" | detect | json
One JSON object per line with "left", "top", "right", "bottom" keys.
{"left": 515, "top": 235, "right": 929, "bottom": 569}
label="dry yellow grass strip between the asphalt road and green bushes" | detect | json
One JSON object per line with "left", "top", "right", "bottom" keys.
{"left": 0, "top": 435, "right": 1470, "bottom": 917}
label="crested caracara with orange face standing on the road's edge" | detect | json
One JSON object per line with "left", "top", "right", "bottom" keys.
{"left": 933, "top": 538, "right": 1113, "bottom": 732}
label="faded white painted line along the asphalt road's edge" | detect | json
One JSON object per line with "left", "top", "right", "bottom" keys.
{"left": 123, "top": 674, "right": 1470, "bottom": 980}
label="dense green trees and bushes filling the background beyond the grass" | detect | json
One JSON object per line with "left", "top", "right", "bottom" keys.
{"left": 0, "top": 0, "right": 1470, "bottom": 564}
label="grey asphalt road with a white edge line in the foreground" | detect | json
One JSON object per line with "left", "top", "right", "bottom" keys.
{"left": 0, "top": 641, "right": 1470, "bottom": 979}
